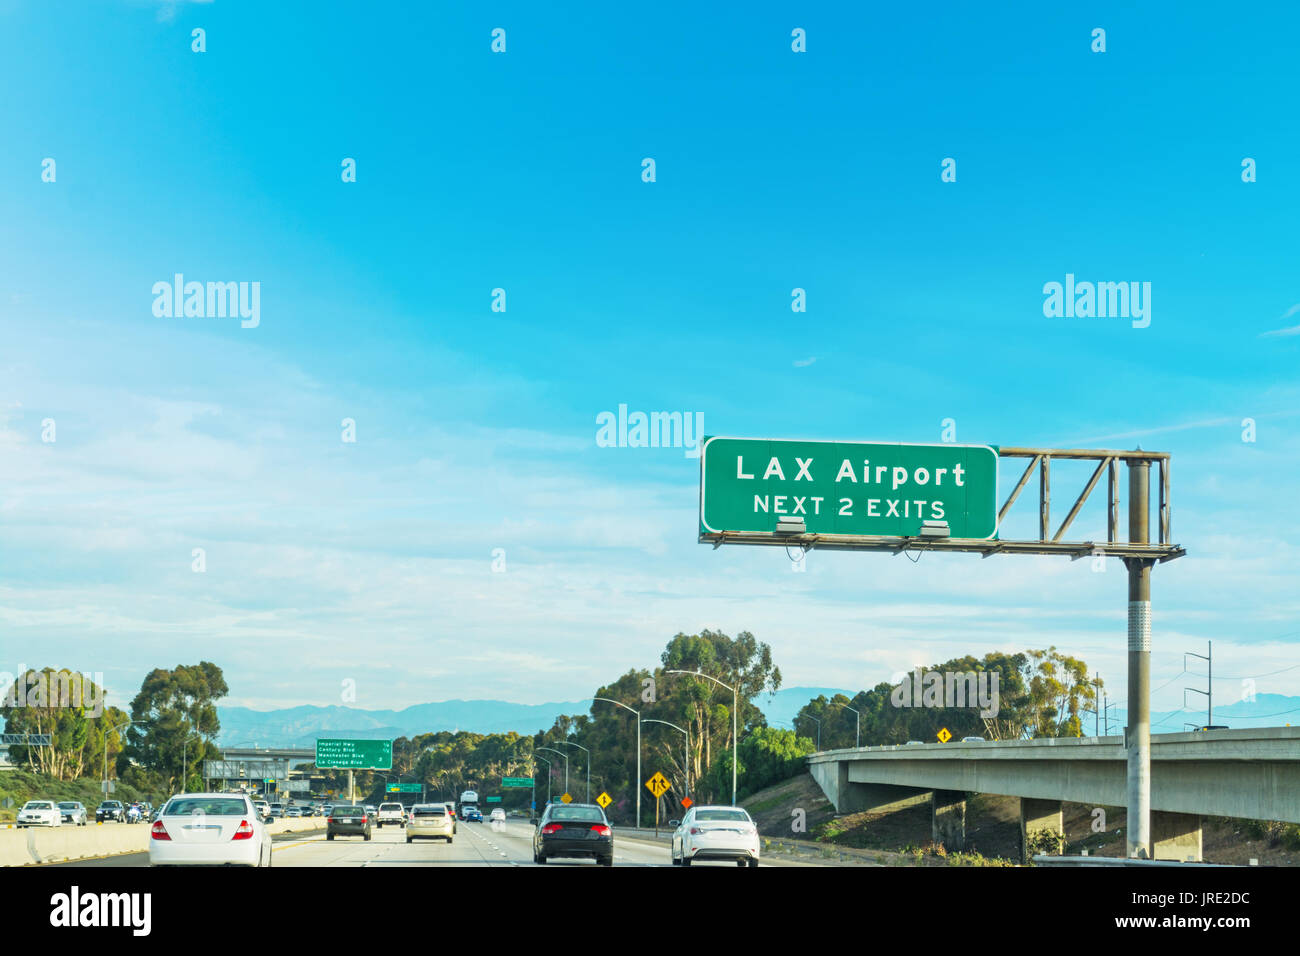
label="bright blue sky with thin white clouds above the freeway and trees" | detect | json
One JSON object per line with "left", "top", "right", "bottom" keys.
{"left": 0, "top": 0, "right": 1300, "bottom": 723}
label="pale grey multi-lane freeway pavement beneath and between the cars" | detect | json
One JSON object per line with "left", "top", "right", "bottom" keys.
{"left": 48, "top": 821, "right": 811, "bottom": 869}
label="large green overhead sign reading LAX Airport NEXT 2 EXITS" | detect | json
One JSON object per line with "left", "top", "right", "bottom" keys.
{"left": 699, "top": 437, "right": 997, "bottom": 538}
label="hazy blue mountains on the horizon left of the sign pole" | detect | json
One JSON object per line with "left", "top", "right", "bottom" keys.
{"left": 217, "top": 687, "right": 839, "bottom": 747}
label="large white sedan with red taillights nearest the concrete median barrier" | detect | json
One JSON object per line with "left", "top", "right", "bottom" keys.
{"left": 150, "top": 793, "right": 270, "bottom": 866}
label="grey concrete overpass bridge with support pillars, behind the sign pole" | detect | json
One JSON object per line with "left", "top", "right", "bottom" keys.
{"left": 807, "top": 727, "right": 1300, "bottom": 861}
